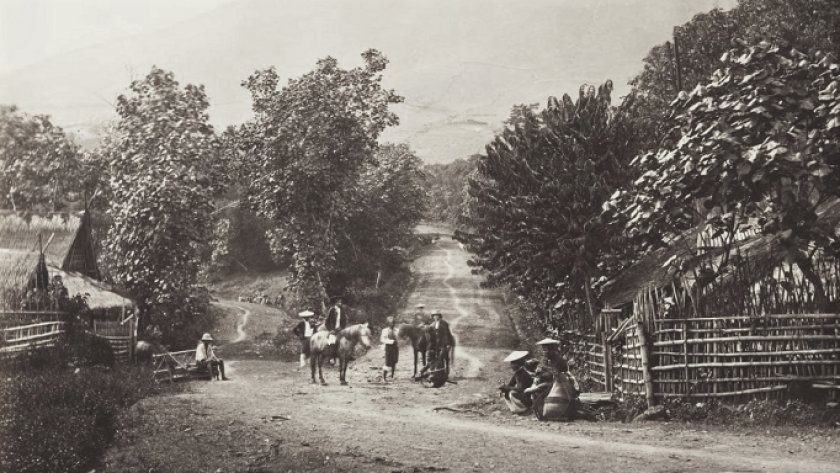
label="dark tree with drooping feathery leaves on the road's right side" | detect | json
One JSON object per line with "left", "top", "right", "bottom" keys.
{"left": 469, "top": 81, "right": 636, "bottom": 324}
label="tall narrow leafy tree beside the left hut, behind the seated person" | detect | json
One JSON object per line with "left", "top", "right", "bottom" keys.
{"left": 101, "top": 67, "right": 227, "bottom": 330}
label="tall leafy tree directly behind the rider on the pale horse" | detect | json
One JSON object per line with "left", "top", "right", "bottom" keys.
{"left": 237, "top": 50, "right": 402, "bottom": 303}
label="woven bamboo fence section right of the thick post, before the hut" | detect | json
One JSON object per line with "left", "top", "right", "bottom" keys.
{"left": 651, "top": 314, "right": 840, "bottom": 400}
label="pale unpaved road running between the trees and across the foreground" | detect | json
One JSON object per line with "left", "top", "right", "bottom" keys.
{"left": 136, "top": 228, "right": 840, "bottom": 472}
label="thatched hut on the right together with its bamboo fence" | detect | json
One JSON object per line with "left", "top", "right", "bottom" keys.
{"left": 586, "top": 202, "right": 840, "bottom": 405}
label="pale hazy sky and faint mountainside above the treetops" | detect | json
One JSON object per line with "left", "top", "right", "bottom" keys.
{"left": 0, "top": 0, "right": 734, "bottom": 163}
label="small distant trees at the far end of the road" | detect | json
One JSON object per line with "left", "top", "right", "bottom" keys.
{"left": 423, "top": 155, "right": 479, "bottom": 227}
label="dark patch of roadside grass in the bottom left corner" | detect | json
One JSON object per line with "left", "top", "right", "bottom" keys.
{"left": 0, "top": 337, "right": 182, "bottom": 473}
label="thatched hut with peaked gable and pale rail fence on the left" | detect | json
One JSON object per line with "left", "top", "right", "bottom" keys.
{"left": 0, "top": 211, "right": 136, "bottom": 361}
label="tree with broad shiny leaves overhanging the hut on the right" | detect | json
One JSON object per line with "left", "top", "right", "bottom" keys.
{"left": 605, "top": 41, "right": 840, "bottom": 309}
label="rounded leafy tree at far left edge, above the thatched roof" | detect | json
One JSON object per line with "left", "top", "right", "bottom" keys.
{"left": 0, "top": 105, "right": 95, "bottom": 211}
